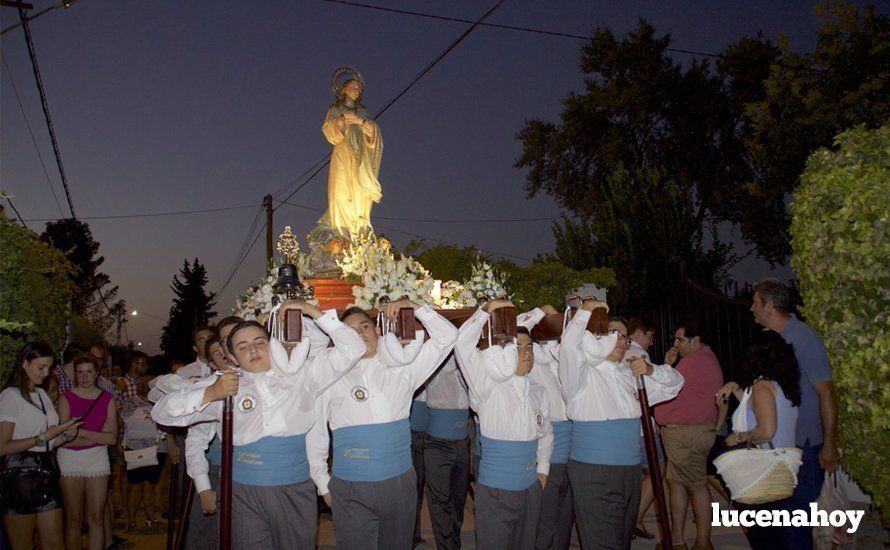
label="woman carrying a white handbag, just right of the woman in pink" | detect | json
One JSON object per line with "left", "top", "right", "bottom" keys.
{"left": 121, "top": 376, "right": 167, "bottom": 531}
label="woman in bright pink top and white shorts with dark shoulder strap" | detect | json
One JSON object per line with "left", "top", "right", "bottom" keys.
{"left": 58, "top": 355, "right": 117, "bottom": 550}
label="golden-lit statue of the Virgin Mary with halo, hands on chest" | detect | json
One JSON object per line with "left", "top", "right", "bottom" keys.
{"left": 318, "top": 67, "right": 383, "bottom": 239}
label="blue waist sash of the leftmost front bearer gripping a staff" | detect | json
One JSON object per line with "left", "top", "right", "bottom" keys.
{"left": 232, "top": 434, "right": 309, "bottom": 487}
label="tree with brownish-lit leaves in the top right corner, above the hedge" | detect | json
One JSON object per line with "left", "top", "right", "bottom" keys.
{"left": 736, "top": 3, "right": 890, "bottom": 262}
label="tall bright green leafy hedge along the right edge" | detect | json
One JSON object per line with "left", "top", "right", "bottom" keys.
{"left": 791, "top": 126, "right": 890, "bottom": 506}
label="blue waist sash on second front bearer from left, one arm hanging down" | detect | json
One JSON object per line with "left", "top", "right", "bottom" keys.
{"left": 334, "top": 418, "right": 411, "bottom": 481}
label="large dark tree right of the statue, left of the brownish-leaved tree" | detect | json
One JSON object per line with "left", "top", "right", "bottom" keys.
{"left": 516, "top": 20, "right": 774, "bottom": 308}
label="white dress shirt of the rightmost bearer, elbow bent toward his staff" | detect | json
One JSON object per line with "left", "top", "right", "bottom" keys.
{"left": 559, "top": 310, "right": 684, "bottom": 421}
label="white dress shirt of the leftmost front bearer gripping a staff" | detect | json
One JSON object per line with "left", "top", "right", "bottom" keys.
{"left": 152, "top": 310, "right": 365, "bottom": 494}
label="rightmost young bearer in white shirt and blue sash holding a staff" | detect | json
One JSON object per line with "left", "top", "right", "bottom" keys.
{"left": 559, "top": 300, "right": 683, "bottom": 548}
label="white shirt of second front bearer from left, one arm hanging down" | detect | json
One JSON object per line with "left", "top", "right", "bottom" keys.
{"left": 306, "top": 306, "right": 457, "bottom": 495}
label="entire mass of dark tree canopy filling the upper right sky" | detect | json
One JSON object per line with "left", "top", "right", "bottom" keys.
{"left": 516, "top": 4, "right": 890, "bottom": 308}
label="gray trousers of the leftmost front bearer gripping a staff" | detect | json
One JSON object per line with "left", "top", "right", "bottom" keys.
{"left": 232, "top": 479, "right": 318, "bottom": 550}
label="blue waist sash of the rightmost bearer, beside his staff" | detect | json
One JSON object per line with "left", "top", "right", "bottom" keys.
{"left": 570, "top": 418, "right": 640, "bottom": 466}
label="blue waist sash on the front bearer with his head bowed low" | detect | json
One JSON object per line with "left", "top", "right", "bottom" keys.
{"left": 479, "top": 435, "right": 538, "bottom": 491}
